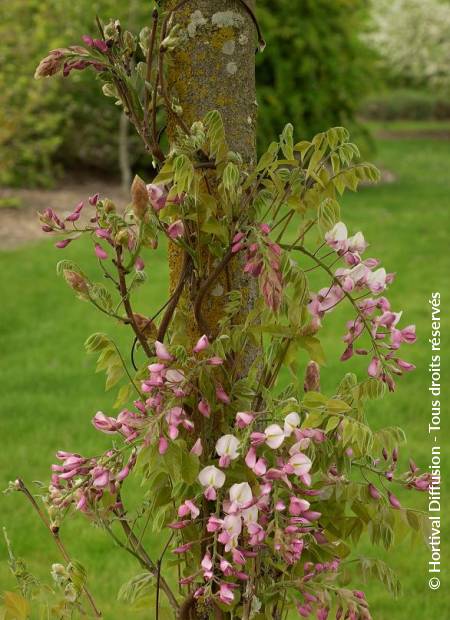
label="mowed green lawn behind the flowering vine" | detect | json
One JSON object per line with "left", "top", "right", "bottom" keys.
{"left": 0, "top": 133, "right": 450, "bottom": 620}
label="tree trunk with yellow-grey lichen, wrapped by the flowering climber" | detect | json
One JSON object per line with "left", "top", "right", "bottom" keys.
{"left": 167, "top": 0, "right": 257, "bottom": 358}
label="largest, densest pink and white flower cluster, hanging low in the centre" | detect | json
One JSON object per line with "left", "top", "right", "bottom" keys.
{"left": 170, "top": 411, "right": 326, "bottom": 604}
